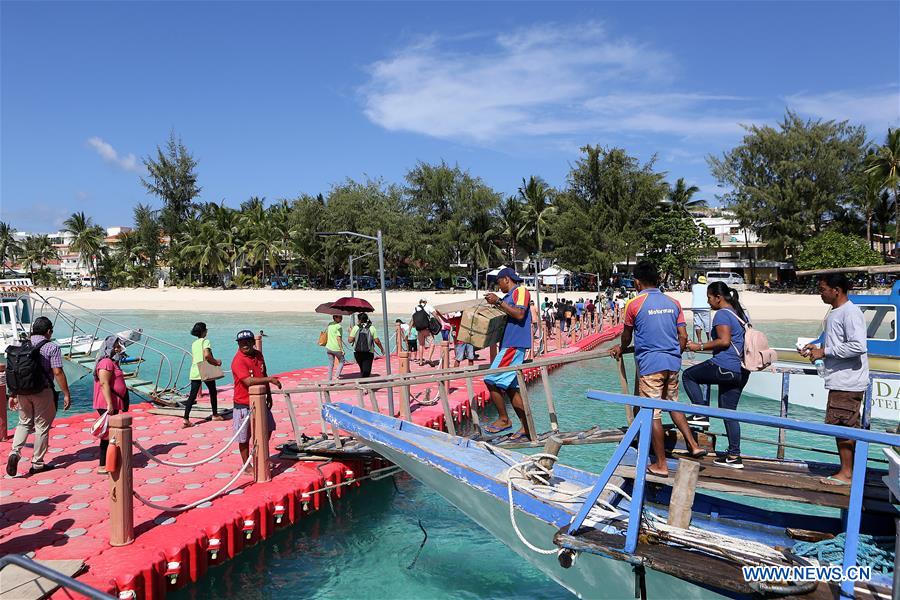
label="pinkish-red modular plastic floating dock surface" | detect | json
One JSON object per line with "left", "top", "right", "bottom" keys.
{"left": 0, "top": 327, "right": 621, "bottom": 598}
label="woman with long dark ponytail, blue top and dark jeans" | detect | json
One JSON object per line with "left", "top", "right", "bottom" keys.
{"left": 682, "top": 281, "right": 750, "bottom": 469}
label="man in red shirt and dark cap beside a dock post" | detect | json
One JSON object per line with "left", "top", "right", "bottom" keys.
{"left": 231, "top": 329, "right": 281, "bottom": 475}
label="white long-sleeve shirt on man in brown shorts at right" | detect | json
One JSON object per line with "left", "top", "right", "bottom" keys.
{"left": 824, "top": 300, "right": 869, "bottom": 392}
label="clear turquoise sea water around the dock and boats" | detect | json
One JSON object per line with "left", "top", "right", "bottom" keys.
{"left": 19, "top": 311, "right": 892, "bottom": 599}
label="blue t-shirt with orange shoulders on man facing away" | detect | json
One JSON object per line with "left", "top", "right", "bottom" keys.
{"left": 625, "top": 288, "right": 685, "bottom": 375}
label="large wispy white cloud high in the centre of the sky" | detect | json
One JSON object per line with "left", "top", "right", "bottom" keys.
{"left": 361, "top": 23, "right": 757, "bottom": 143}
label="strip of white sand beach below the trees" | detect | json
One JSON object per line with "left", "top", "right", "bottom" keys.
{"left": 41, "top": 287, "right": 826, "bottom": 321}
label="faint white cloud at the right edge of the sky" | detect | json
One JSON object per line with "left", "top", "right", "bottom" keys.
{"left": 784, "top": 85, "right": 900, "bottom": 134}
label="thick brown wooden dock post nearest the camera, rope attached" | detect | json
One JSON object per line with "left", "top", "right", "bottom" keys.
{"left": 106, "top": 414, "right": 134, "bottom": 546}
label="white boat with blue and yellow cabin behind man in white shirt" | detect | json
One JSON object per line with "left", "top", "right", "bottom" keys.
{"left": 744, "top": 265, "right": 900, "bottom": 427}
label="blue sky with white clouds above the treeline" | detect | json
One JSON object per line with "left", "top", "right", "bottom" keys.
{"left": 0, "top": 1, "right": 900, "bottom": 231}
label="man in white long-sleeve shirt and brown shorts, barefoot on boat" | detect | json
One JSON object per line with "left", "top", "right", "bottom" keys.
{"left": 802, "top": 273, "right": 869, "bottom": 485}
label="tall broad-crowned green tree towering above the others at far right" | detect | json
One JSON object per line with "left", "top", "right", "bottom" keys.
{"left": 707, "top": 111, "right": 866, "bottom": 254}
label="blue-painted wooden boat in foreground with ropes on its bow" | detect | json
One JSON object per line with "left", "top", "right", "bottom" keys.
{"left": 323, "top": 373, "right": 900, "bottom": 600}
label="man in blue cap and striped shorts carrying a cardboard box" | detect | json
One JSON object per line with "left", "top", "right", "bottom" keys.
{"left": 484, "top": 267, "right": 534, "bottom": 441}
